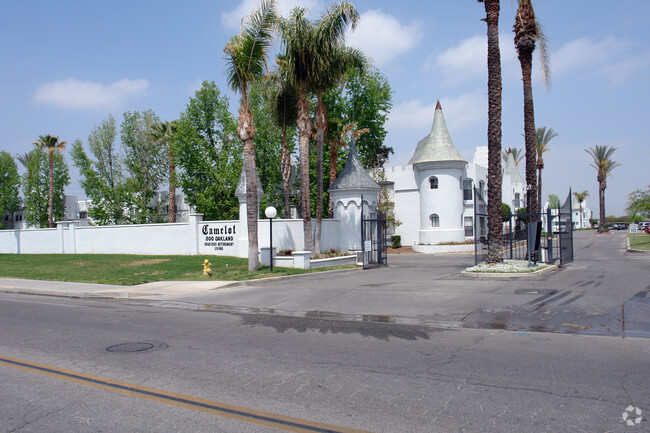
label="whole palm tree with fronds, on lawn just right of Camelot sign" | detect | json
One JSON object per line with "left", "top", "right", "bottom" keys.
{"left": 224, "top": 0, "right": 276, "bottom": 271}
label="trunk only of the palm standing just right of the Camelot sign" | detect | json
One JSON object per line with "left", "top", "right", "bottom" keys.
{"left": 237, "top": 92, "right": 259, "bottom": 271}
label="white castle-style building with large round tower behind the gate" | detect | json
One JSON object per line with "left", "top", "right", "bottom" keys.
{"left": 382, "top": 102, "right": 526, "bottom": 245}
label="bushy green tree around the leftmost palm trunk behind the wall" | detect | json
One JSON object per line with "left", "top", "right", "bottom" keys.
{"left": 22, "top": 147, "right": 70, "bottom": 228}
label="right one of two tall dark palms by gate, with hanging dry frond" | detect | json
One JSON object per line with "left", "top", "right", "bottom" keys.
{"left": 514, "top": 0, "right": 549, "bottom": 221}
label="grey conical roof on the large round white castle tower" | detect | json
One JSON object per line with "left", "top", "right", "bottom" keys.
{"left": 409, "top": 101, "right": 467, "bottom": 164}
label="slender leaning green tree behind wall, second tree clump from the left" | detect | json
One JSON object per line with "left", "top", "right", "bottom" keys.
{"left": 71, "top": 115, "right": 127, "bottom": 225}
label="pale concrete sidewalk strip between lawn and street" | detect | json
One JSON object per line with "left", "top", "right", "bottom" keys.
{"left": 0, "top": 278, "right": 238, "bottom": 300}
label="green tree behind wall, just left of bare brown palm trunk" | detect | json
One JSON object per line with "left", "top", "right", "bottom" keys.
{"left": 120, "top": 110, "right": 166, "bottom": 224}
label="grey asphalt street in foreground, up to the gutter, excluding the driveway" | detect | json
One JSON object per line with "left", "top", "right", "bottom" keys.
{"left": 0, "top": 295, "right": 650, "bottom": 432}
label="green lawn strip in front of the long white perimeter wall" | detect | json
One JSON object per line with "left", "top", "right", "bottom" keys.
{"left": 0, "top": 254, "right": 354, "bottom": 286}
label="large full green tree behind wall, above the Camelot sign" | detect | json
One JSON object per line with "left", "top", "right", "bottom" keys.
{"left": 172, "top": 81, "right": 242, "bottom": 220}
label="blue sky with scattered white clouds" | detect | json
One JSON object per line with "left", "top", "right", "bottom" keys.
{"left": 0, "top": 0, "right": 650, "bottom": 217}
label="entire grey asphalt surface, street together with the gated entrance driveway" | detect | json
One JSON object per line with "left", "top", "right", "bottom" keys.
{"left": 0, "top": 232, "right": 650, "bottom": 432}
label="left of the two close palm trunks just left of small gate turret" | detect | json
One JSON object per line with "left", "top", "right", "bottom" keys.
{"left": 297, "top": 89, "right": 314, "bottom": 251}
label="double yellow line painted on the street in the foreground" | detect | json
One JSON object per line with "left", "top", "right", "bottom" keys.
{"left": 0, "top": 356, "right": 367, "bottom": 433}
